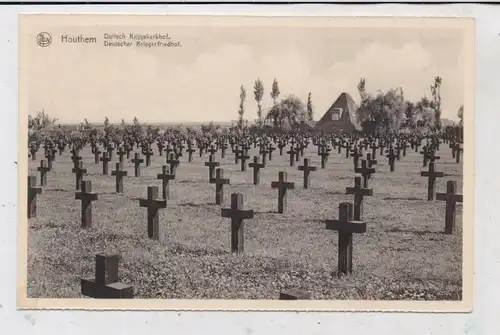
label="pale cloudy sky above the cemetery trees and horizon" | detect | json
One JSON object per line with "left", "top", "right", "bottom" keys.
{"left": 21, "top": 18, "right": 464, "bottom": 123}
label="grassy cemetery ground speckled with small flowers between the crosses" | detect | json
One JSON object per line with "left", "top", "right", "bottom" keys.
{"left": 27, "top": 140, "right": 462, "bottom": 300}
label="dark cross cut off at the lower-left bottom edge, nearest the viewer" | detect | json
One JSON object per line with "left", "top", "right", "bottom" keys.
{"left": 80, "top": 254, "right": 134, "bottom": 299}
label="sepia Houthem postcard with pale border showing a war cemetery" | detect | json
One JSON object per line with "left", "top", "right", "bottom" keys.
{"left": 17, "top": 14, "right": 474, "bottom": 312}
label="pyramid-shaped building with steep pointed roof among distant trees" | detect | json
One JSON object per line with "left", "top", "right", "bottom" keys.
{"left": 314, "top": 92, "right": 362, "bottom": 134}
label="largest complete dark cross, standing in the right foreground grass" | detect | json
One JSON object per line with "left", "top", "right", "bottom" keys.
{"left": 326, "top": 202, "right": 366, "bottom": 277}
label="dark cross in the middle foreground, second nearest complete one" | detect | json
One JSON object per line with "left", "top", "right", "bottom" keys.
{"left": 221, "top": 193, "right": 253, "bottom": 254}
